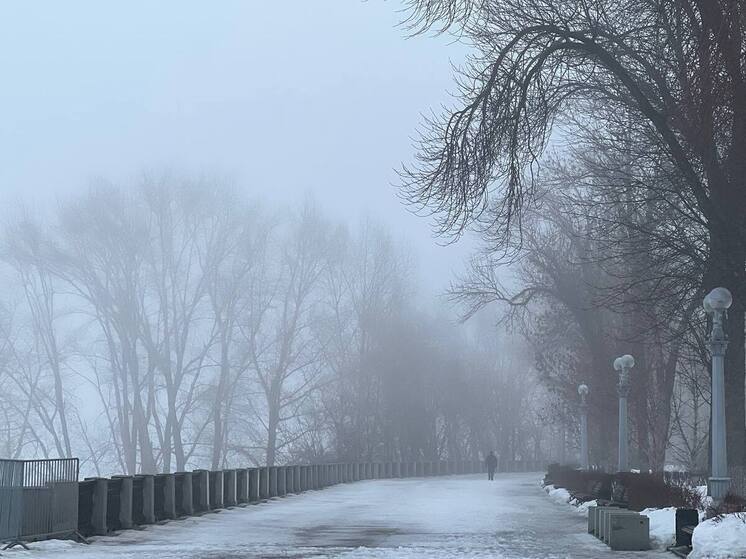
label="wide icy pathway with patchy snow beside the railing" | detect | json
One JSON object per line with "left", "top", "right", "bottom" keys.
{"left": 18, "top": 474, "right": 668, "bottom": 559}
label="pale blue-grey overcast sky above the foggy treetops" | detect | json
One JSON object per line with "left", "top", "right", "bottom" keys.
{"left": 0, "top": 0, "right": 469, "bottom": 300}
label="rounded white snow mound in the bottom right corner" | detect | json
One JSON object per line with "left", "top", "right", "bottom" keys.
{"left": 689, "top": 514, "right": 746, "bottom": 559}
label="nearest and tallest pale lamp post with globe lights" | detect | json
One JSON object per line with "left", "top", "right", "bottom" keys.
{"left": 704, "top": 287, "right": 733, "bottom": 501}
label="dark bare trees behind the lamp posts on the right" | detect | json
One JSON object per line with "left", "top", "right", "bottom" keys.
{"left": 403, "top": 0, "right": 746, "bottom": 468}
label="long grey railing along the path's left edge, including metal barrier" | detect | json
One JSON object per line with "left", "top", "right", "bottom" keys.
{"left": 0, "top": 459, "right": 544, "bottom": 545}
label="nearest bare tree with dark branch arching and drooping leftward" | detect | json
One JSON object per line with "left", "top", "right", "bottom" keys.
{"left": 404, "top": 0, "right": 746, "bottom": 465}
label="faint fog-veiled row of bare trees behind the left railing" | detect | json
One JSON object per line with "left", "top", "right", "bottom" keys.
{"left": 0, "top": 175, "right": 543, "bottom": 474}
